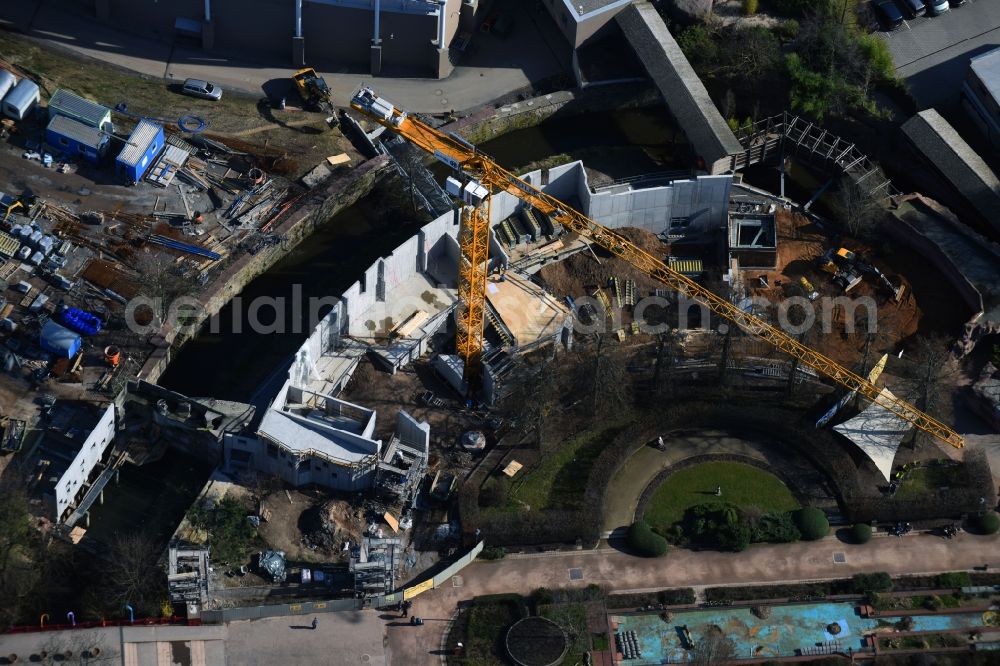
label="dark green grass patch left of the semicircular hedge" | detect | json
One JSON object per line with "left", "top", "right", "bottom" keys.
{"left": 511, "top": 424, "right": 624, "bottom": 511}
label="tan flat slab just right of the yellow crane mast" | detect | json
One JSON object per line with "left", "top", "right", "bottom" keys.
{"left": 486, "top": 273, "right": 570, "bottom": 346}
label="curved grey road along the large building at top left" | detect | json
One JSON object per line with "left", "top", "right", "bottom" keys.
{"left": 0, "top": 0, "right": 569, "bottom": 113}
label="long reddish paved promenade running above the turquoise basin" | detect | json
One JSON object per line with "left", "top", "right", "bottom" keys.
{"left": 387, "top": 534, "right": 1000, "bottom": 666}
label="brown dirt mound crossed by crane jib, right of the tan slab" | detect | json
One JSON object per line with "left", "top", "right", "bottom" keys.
{"left": 539, "top": 228, "right": 668, "bottom": 298}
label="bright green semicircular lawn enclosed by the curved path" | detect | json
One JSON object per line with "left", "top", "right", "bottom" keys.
{"left": 642, "top": 462, "right": 799, "bottom": 531}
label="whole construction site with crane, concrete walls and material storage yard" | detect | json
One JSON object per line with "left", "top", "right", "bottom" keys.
{"left": 0, "top": 3, "right": 1000, "bottom": 649}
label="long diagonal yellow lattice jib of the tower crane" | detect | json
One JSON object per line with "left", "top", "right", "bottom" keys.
{"left": 351, "top": 91, "right": 965, "bottom": 448}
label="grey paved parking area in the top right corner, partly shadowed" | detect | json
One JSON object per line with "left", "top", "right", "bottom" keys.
{"left": 881, "top": 0, "right": 1000, "bottom": 109}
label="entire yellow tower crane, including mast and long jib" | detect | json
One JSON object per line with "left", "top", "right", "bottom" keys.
{"left": 351, "top": 86, "right": 965, "bottom": 448}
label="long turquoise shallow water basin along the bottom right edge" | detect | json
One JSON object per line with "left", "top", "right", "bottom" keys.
{"left": 614, "top": 602, "right": 982, "bottom": 666}
